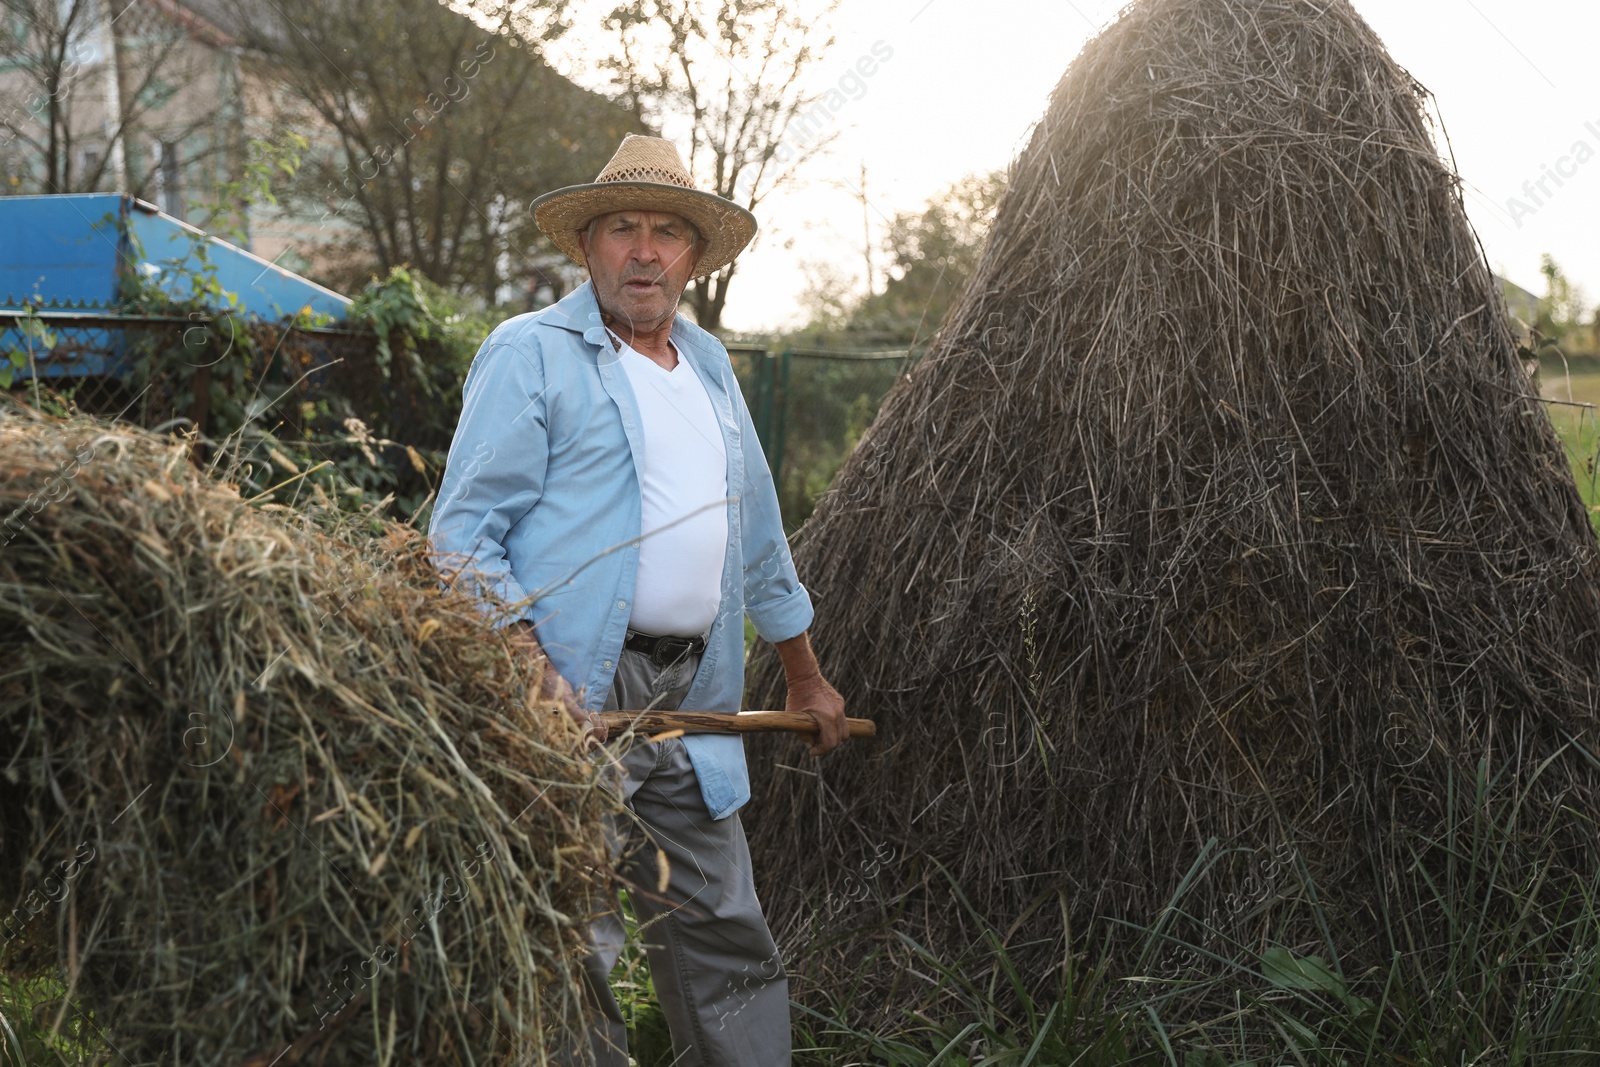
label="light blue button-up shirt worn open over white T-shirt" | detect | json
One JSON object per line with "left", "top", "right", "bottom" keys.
{"left": 429, "top": 283, "right": 811, "bottom": 819}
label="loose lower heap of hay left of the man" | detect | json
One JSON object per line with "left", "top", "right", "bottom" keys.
{"left": 0, "top": 410, "right": 606, "bottom": 1067}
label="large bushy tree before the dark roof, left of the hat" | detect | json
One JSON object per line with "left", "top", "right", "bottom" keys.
{"left": 235, "top": 0, "right": 640, "bottom": 302}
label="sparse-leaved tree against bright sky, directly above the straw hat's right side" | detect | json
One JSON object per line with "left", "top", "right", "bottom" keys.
{"left": 606, "top": 0, "right": 845, "bottom": 331}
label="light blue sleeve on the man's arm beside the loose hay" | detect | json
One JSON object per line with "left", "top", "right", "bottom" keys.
{"left": 429, "top": 325, "right": 550, "bottom": 625}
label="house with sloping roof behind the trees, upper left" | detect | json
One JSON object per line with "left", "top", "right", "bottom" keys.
{"left": 0, "top": 0, "right": 642, "bottom": 306}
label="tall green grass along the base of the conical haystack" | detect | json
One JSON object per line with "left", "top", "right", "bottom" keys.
{"left": 777, "top": 768, "right": 1600, "bottom": 1067}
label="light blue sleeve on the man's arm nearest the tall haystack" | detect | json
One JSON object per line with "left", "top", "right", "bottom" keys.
{"left": 733, "top": 389, "right": 813, "bottom": 643}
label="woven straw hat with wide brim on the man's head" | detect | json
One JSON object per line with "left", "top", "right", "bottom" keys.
{"left": 533, "top": 133, "right": 755, "bottom": 278}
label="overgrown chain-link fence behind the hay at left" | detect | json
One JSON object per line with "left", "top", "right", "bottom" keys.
{"left": 0, "top": 301, "right": 461, "bottom": 517}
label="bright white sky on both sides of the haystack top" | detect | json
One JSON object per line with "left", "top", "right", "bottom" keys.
{"left": 540, "top": 0, "right": 1600, "bottom": 331}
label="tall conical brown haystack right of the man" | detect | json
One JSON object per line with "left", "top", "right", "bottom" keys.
{"left": 750, "top": 0, "right": 1600, "bottom": 1011}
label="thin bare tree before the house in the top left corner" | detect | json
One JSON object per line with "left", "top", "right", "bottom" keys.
{"left": 0, "top": 0, "right": 228, "bottom": 199}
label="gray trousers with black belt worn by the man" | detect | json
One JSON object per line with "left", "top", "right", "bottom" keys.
{"left": 584, "top": 649, "right": 789, "bottom": 1067}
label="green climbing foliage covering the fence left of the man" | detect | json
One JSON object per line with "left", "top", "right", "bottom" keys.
{"left": 51, "top": 225, "right": 494, "bottom": 520}
